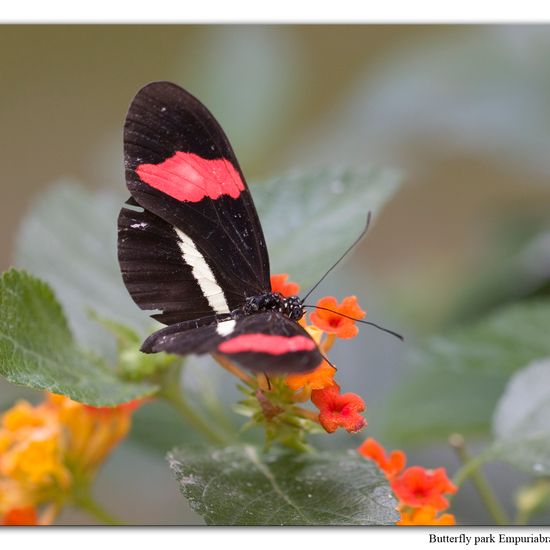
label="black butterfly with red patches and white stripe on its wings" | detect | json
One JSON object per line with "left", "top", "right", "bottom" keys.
{"left": 118, "top": 82, "right": 323, "bottom": 373}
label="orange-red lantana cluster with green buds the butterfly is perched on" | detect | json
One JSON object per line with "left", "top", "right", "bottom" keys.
{"left": 214, "top": 273, "right": 367, "bottom": 450}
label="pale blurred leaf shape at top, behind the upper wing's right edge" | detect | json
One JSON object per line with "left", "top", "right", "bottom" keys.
{"left": 181, "top": 25, "right": 305, "bottom": 174}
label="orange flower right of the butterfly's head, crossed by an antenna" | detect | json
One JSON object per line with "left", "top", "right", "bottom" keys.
{"left": 310, "top": 296, "right": 366, "bottom": 338}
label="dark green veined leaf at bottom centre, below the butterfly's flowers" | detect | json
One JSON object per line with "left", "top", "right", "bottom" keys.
{"left": 168, "top": 445, "right": 399, "bottom": 525}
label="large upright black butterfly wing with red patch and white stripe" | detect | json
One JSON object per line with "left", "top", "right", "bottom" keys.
{"left": 118, "top": 82, "right": 270, "bottom": 324}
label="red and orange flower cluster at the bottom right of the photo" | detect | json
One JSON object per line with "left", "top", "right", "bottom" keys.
{"left": 357, "top": 438, "right": 457, "bottom": 525}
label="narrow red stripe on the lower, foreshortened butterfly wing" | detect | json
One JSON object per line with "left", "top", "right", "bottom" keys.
{"left": 218, "top": 333, "right": 316, "bottom": 355}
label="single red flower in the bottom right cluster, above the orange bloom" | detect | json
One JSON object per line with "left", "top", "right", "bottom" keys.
{"left": 391, "top": 466, "right": 457, "bottom": 510}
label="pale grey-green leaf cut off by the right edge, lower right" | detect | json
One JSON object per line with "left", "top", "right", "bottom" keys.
{"left": 490, "top": 358, "right": 550, "bottom": 476}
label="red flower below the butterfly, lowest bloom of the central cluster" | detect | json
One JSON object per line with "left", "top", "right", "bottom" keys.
{"left": 311, "top": 384, "right": 367, "bottom": 433}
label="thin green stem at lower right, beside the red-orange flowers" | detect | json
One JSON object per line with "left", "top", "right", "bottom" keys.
{"left": 449, "top": 434, "right": 510, "bottom": 525}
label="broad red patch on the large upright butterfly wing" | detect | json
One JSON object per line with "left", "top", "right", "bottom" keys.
{"left": 136, "top": 151, "right": 244, "bottom": 202}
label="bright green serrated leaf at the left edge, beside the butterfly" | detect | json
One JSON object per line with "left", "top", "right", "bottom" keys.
{"left": 0, "top": 269, "right": 157, "bottom": 406}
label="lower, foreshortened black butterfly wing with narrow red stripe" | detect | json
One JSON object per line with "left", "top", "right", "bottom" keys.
{"left": 141, "top": 311, "right": 323, "bottom": 374}
